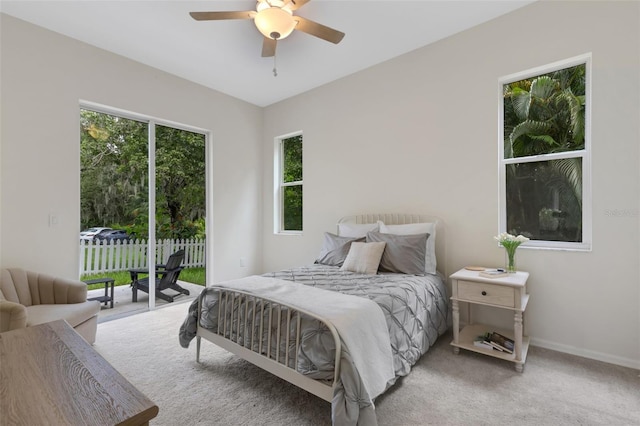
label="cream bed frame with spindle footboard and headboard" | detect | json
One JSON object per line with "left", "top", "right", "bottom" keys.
{"left": 196, "top": 213, "right": 445, "bottom": 402}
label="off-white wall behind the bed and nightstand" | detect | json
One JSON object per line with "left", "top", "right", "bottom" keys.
{"left": 263, "top": 1, "right": 640, "bottom": 368}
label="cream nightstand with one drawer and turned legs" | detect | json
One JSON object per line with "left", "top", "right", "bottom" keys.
{"left": 450, "top": 269, "right": 529, "bottom": 373}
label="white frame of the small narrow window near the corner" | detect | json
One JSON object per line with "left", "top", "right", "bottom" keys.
{"left": 273, "top": 130, "right": 304, "bottom": 235}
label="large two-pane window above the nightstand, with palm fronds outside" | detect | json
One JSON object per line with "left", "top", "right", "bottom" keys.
{"left": 499, "top": 55, "right": 591, "bottom": 250}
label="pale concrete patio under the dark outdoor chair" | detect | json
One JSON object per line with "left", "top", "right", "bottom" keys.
{"left": 87, "top": 281, "right": 204, "bottom": 324}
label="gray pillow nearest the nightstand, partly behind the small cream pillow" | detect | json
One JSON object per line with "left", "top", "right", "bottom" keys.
{"left": 367, "top": 232, "right": 429, "bottom": 275}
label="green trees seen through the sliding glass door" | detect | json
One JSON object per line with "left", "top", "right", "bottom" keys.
{"left": 80, "top": 110, "right": 206, "bottom": 239}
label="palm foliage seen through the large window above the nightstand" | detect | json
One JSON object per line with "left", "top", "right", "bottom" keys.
{"left": 503, "top": 64, "right": 586, "bottom": 242}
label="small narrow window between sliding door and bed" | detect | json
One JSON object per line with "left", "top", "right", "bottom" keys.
{"left": 274, "top": 133, "right": 302, "bottom": 234}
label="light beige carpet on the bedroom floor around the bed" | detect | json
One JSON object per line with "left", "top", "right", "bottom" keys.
{"left": 95, "top": 303, "right": 640, "bottom": 426}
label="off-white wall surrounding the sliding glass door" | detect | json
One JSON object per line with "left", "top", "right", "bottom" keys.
{"left": 0, "top": 15, "right": 262, "bottom": 280}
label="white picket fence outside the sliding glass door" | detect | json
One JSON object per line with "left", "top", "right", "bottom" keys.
{"left": 80, "top": 239, "right": 205, "bottom": 276}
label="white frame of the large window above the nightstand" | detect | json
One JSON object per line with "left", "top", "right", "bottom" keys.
{"left": 498, "top": 53, "right": 592, "bottom": 251}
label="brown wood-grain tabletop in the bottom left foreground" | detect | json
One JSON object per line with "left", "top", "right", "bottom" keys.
{"left": 0, "top": 320, "right": 158, "bottom": 425}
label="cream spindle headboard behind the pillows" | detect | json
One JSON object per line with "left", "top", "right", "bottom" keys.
{"left": 338, "top": 213, "right": 447, "bottom": 279}
